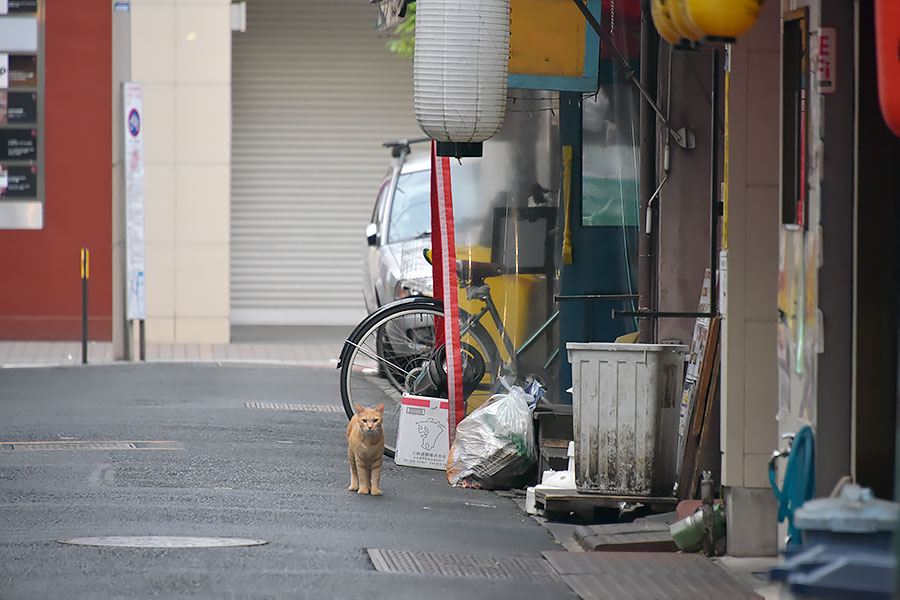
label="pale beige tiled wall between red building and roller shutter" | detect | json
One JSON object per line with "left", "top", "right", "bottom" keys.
{"left": 131, "top": 0, "right": 231, "bottom": 343}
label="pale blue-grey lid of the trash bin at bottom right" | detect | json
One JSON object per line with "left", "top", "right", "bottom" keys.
{"left": 794, "top": 483, "right": 900, "bottom": 533}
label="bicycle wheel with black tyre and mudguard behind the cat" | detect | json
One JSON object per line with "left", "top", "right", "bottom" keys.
{"left": 340, "top": 297, "right": 498, "bottom": 457}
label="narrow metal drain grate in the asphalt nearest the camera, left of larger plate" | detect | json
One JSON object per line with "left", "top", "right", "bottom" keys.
{"left": 368, "top": 548, "right": 559, "bottom": 582}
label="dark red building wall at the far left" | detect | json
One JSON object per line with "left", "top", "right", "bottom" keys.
{"left": 0, "top": 0, "right": 112, "bottom": 340}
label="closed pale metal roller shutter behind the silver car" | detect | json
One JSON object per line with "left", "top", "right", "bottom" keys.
{"left": 231, "top": 0, "right": 422, "bottom": 325}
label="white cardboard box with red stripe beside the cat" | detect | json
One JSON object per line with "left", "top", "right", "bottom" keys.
{"left": 394, "top": 396, "right": 450, "bottom": 471}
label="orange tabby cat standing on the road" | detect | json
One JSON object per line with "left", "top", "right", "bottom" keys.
{"left": 347, "top": 403, "right": 384, "bottom": 496}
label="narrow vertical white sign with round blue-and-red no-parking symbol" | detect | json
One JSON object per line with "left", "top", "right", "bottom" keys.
{"left": 123, "top": 83, "right": 146, "bottom": 320}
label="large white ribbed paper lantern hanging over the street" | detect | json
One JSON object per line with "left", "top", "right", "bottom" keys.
{"left": 413, "top": 0, "right": 509, "bottom": 143}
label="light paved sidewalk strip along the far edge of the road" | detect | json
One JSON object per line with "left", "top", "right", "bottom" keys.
{"left": 0, "top": 327, "right": 350, "bottom": 368}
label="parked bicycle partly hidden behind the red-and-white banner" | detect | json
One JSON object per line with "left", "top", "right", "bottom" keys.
{"left": 337, "top": 255, "right": 559, "bottom": 457}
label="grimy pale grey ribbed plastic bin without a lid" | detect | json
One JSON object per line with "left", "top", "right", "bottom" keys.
{"left": 566, "top": 342, "right": 688, "bottom": 496}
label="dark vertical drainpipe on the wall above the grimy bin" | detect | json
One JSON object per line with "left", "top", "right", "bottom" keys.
{"left": 637, "top": 0, "right": 659, "bottom": 343}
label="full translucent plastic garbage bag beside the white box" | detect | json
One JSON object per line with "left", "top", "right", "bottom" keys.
{"left": 447, "top": 386, "right": 537, "bottom": 490}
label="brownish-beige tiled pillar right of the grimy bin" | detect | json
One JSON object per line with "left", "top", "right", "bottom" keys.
{"left": 722, "top": 2, "right": 781, "bottom": 490}
